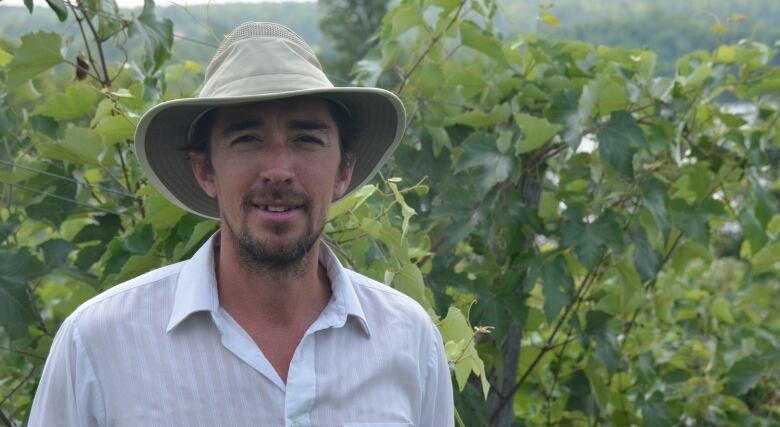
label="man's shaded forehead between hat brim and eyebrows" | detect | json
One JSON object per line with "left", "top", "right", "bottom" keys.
{"left": 215, "top": 97, "right": 334, "bottom": 128}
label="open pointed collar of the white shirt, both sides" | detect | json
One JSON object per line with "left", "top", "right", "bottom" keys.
{"left": 166, "top": 232, "right": 371, "bottom": 338}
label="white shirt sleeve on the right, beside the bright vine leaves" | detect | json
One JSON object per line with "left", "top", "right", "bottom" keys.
{"left": 420, "top": 324, "right": 455, "bottom": 427}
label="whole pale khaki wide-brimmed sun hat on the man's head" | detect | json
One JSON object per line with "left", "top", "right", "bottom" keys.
{"left": 135, "top": 22, "right": 406, "bottom": 218}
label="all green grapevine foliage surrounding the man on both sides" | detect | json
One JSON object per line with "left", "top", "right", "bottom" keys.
{"left": 0, "top": 0, "right": 780, "bottom": 426}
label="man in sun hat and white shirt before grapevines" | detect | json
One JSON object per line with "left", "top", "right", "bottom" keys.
{"left": 30, "top": 23, "right": 453, "bottom": 427}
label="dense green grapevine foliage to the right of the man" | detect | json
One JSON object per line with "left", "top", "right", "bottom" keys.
{"left": 357, "top": 0, "right": 780, "bottom": 425}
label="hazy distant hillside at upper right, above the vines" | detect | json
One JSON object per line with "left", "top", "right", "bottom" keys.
{"left": 496, "top": 0, "right": 780, "bottom": 64}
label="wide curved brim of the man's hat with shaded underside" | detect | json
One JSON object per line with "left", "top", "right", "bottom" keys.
{"left": 135, "top": 87, "right": 406, "bottom": 219}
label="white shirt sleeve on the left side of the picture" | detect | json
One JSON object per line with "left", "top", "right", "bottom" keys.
{"left": 28, "top": 318, "right": 106, "bottom": 427}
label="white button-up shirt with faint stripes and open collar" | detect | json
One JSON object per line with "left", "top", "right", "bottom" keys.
{"left": 30, "top": 236, "right": 454, "bottom": 427}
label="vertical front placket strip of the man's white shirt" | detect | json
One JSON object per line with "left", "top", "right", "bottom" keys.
{"left": 284, "top": 332, "right": 317, "bottom": 427}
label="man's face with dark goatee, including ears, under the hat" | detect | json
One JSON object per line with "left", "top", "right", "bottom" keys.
{"left": 191, "top": 98, "right": 354, "bottom": 269}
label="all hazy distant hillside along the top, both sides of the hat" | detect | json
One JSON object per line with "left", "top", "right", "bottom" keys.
{"left": 0, "top": 0, "right": 780, "bottom": 74}
